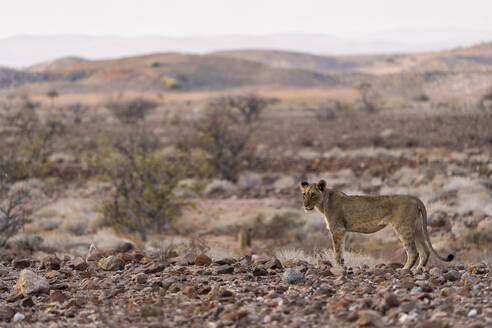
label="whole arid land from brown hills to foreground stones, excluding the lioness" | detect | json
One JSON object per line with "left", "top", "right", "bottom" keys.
{"left": 0, "top": 43, "right": 492, "bottom": 328}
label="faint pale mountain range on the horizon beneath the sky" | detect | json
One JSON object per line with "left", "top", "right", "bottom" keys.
{"left": 0, "top": 29, "right": 491, "bottom": 68}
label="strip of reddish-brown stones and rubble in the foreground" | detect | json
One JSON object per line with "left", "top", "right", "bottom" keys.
{"left": 0, "top": 247, "right": 492, "bottom": 328}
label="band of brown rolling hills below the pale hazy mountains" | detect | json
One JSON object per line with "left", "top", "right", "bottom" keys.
{"left": 0, "top": 43, "right": 492, "bottom": 97}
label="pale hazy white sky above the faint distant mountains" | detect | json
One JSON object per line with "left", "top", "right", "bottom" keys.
{"left": 0, "top": 0, "right": 492, "bottom": 41}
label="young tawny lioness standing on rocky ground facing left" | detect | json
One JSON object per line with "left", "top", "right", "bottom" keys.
{"left": 300, "top": 180, "right": 454, "bottom": 269}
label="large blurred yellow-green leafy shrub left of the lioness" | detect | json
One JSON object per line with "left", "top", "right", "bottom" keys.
{"left": 100, "top": 134, "right": 188, "bottom": 241}
